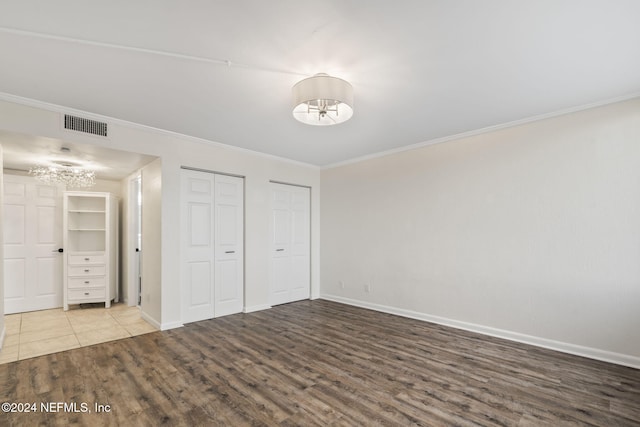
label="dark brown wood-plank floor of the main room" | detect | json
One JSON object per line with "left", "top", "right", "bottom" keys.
{"left": 0, "top": 300, "right": 640, "bottom": 427}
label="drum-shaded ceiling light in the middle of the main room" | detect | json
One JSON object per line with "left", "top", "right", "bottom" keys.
{"left": 292, "top": 73, "right": 353, "bottom": 126}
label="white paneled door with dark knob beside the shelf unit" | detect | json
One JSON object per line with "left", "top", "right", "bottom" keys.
{"left": 3, "top": 175, "right": 64, "bottom": 314}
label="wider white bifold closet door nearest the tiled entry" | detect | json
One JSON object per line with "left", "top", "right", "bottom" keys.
{"left": 181, "top": 169, "right": 244, "bottom": 323}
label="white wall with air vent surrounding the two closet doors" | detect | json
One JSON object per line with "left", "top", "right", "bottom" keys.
{"left": 0, "top": 97, "right": 320, "bottom": 328}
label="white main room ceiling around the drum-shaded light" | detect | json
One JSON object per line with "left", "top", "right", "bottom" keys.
{"left": 0, "top": 0, "right": 640, "bottom": 166}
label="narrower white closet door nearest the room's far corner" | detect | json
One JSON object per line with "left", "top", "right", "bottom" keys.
{"left": 269, "top": 183, "right": 311, "bottom": 305}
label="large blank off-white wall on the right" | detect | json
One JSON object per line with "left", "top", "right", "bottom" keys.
{"left": 321, "top": 99, "right": 640, "bottom": 367}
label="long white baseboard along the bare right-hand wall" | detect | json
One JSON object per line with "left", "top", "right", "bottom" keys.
{"left": 320, "top": 295, "right": 640, "bottom": 369}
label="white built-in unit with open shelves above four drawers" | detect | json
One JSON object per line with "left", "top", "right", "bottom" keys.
{"left": 63, "top": 191, "right": 118, "bottom": 310}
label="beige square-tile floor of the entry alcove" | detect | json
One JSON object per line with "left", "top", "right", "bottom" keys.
{"left": 0, "top": 303, "right": 157, "bottom": 363}
